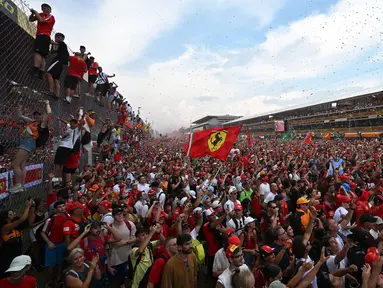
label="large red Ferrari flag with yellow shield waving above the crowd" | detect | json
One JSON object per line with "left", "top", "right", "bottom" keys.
{"left": 185, "top": 125, "right": 242, "bottom": 160}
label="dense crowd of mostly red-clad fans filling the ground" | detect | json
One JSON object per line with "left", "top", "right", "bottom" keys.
{"left": 0, "top": 129, "right": 383, "bottom": 288}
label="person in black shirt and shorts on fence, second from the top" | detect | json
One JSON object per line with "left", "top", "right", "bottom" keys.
{"left": 46, "top": 33, "right": 69, "bottom": 98}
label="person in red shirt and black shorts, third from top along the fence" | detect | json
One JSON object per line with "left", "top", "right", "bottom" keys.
{"left": 64, "top": 52, "right": 87, "bottom": 104}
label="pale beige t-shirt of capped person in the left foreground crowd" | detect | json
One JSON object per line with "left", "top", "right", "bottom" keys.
{"left": 109, "top": 221, "right": 137, "bottom": 266}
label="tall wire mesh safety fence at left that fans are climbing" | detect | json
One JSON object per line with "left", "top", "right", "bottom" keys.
{"left": 0, "top": 0, "right": 117, "bottom": 212}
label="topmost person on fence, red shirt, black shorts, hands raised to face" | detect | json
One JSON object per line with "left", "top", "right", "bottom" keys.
{"left": 29, "top": 3, "right": 56, "bottom": 79}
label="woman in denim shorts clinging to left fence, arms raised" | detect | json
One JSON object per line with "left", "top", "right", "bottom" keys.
{"left": 9, "top": 100, "right": 52, "bottom": 193}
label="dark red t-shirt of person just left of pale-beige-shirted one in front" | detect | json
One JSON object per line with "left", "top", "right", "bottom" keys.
{"left": 80, "top": 235, "right": 111, "bottom": 272}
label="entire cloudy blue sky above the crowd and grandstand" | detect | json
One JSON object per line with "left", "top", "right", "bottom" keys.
{"left": 28, "top": 0, "right": 383, "bottom": 131}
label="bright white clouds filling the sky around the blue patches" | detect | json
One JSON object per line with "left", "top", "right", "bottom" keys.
{"left": 24, "top": 0, "right": 383, "bottom": 131}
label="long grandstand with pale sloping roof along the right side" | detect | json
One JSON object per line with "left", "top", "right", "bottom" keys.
{"left": 224, "top": 89, "right": 383, "bottom": 137}
